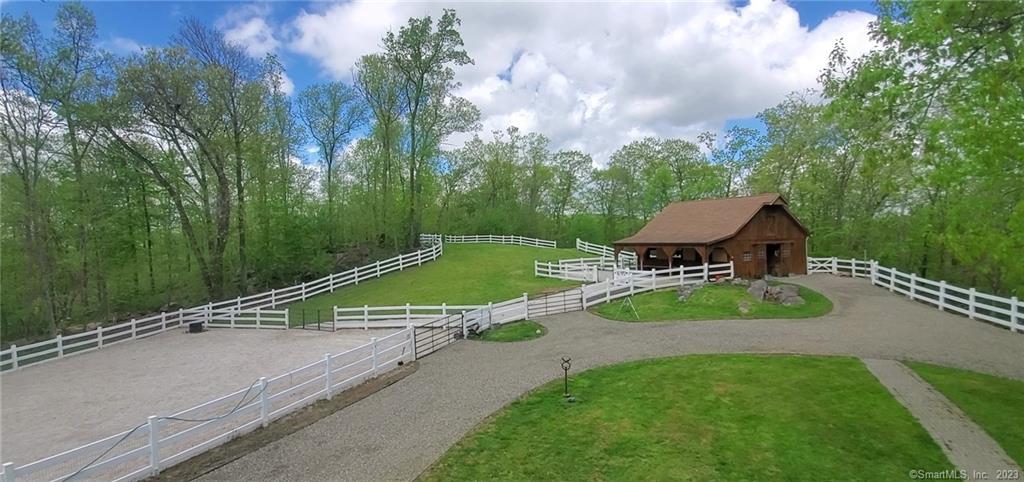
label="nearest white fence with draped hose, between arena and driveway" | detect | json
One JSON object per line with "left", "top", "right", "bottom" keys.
{"left": 0, "top": 328, "right": 416, "bottom": 482}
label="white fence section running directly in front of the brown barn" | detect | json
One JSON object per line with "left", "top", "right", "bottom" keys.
{"left": 583, "top": 261, "right": 734, "bottom": 309}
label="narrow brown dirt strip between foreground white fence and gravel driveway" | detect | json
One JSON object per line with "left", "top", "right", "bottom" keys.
{"left": 146, "top": 361, "right": 419, "bottom": 481}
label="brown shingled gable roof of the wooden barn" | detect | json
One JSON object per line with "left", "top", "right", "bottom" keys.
{"left": 615, "top": 192, "right": 807, "bottom": 245}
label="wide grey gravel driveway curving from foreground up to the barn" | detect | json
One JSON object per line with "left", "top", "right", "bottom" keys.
{"left": 199, "top": 275, "right": 1024, "bottom": 481}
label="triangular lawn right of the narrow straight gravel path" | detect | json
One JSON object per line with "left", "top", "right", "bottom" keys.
{"left": 907, "top": 361, "right": 1024, "bottom": 466}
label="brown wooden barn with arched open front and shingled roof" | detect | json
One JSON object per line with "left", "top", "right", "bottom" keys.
{"left": 614, "top": 193, "right": 808, "bottom": 277}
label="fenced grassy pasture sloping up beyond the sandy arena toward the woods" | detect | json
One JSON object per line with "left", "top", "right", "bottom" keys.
{"left": 288, "top": 244, "right": 587, "bottom": 322}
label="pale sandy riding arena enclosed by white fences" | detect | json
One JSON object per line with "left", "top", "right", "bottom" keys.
{"left": 0, "top": 330, "right": 394, "bottom": 463}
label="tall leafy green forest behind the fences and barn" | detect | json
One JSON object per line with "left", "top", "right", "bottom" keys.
{"left": 0, "top": 2, "right": 1024, "bottom": 341}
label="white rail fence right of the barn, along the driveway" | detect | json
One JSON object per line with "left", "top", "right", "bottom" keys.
{"left": 807, "top": 258, "right": 1024, "bottom": 333}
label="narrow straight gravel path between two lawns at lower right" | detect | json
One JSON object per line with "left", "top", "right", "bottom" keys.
{"left": 864, "top": 358, "right": 1020, "bottom": 480}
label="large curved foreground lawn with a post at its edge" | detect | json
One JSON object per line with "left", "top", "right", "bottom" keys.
{"left": 422, "top": 355, "right": 952, "bottom": 481}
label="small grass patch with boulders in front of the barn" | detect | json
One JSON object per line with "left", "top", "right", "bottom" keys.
{"left": 591, "top": 284, "right": 833, "bottom": 321}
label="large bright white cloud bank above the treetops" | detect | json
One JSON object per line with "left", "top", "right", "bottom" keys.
{"left": 287, "top": 0, "right": 873, "bottom": 162}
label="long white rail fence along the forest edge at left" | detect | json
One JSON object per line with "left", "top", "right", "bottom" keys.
{"left": 0, "top": 245, "right": 444, "bottom": 370}
